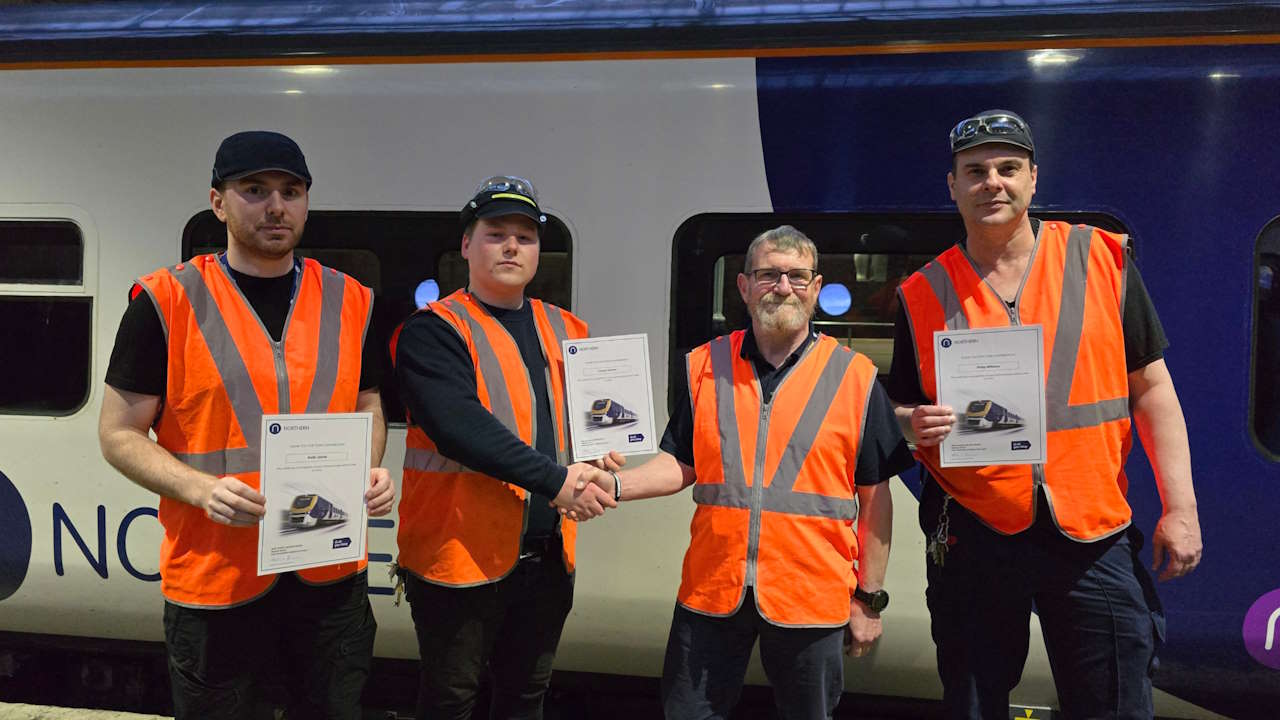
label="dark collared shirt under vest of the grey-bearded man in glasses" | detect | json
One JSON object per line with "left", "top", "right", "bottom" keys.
{"left": 660, "top": 329, "right": 915, "bottom": 486}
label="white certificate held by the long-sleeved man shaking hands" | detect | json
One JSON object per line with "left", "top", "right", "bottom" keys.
{"left": 562, "top": 334, "right": 658, "bottom": 462}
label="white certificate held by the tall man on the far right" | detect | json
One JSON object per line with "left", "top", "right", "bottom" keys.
{"left": 933, "top": 325, "right": 1047, "bottom": 468}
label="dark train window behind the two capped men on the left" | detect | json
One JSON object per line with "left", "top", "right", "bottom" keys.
{"left": 182, "top": 210, "right": 572, "bottom": 423}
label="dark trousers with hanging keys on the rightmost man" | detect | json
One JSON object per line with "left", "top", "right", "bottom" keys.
{"left": 920, "top": 478, "right": 1165, "bottom": 720}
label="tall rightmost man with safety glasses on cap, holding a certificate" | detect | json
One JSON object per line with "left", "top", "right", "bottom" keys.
{"left": 887, "top": 110, "right": 1202, "bottom": 720}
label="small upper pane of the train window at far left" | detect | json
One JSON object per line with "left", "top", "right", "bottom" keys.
{"left": 0, "top": 219, "right": 84, "bottom": 284}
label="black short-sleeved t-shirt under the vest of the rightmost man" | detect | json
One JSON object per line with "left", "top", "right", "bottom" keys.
{"left": 884, "top": 218, "right": 1169, "bottom": 405}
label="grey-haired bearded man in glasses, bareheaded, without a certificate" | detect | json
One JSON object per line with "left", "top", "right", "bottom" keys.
{"left": 612, "top": 225, "right": 911, "bottom": 720}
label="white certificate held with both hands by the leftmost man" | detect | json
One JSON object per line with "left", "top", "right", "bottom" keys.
{"left": 257, "top": 413, "right": 374, "bottom": 575}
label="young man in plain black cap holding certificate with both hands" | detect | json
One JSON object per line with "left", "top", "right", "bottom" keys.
{"left": 99, "top": 132, "right": 394, "bottom": 720}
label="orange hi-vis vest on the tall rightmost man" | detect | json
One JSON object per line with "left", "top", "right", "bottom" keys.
{"left": 899, "top": 222, "right": 1132, "bottom": 541}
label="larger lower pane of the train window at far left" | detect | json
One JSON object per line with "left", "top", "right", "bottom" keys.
{"left": 0, "top": 296, "right": 93, "bottom": 416}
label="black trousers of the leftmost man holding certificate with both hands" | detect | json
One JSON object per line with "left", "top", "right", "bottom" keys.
{"left": 164, "top": 573, "right": 378, "bottom": 720}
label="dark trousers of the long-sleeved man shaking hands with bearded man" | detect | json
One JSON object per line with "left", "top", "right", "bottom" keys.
{"left": 404, "top": 537, "right": 573, "bottom": 720}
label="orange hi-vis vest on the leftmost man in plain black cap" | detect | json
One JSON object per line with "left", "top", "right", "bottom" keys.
{"left": 138, "top": 255, "right": 372, "bottom": 607}
